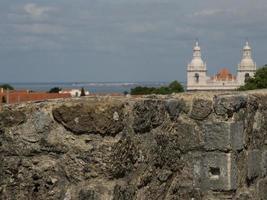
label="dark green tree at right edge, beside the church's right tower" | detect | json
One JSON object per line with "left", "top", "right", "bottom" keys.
{"left": 238, "top": 65, "right": 267, "bottom": 91}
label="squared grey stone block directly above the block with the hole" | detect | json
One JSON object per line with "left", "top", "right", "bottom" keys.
{"left": 202, "top": 122, "right": 243, "bottom": 151}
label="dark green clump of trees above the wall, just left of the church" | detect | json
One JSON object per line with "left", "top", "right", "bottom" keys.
{"left": 131, "top": 81, "right": 184, "bottom": 95}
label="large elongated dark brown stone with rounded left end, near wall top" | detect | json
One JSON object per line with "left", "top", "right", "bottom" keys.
{"left": 53, "top": 104, "right": 123, "bottom": 135}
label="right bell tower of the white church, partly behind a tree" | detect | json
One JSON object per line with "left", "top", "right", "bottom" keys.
{"left": 237, "top": 42, "right": 256, "bottom": 85}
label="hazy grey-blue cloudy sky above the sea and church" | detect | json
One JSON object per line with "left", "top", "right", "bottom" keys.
{"left": 0, "top": 0, "right": 267, "bottom": 82}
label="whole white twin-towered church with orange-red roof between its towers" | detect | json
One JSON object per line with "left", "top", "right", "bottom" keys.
{"left": 187, "top": 42, "right": 256, "bottom": 91}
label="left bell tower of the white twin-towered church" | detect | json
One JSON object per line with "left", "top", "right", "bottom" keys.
{"left": 187, "top": 41, "right": 207, "bottom": 90}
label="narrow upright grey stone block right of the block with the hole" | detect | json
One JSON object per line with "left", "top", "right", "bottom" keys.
{"left": 247, "top": 150, "right": 261, "bottom": 180}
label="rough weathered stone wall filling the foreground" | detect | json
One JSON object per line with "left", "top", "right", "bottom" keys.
{"left": 0, "top": 91, "right": 267, "bottom": 200}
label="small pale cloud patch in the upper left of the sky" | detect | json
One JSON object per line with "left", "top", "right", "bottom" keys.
{"left": 23, "top": 3, "right": 56, "bottom": 17}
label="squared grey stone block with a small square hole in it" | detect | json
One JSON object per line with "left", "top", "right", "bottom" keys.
{"left": 194, "top": 152, "right": 237, "bottom": 191}
